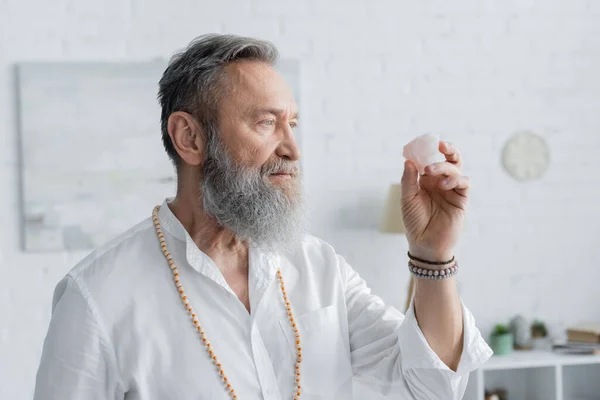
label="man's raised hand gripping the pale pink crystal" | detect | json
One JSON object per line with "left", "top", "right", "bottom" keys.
{"left": 402, "top": 142, "right": 469, "bottom": 261}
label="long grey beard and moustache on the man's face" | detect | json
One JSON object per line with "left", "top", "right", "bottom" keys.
{"left": 200, "top": 133, "right": 305, "bottom": 251}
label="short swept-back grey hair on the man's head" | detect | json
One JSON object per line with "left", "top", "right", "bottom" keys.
{"left": 158, "top": 34, "right": 279, "bottom": 169}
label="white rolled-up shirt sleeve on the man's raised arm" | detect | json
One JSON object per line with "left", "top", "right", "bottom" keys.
{"left": 339, "top": 257, "right": 492, "bottom": 400}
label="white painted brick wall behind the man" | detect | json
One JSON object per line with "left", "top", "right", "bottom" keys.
{"left": 0, "top": 0, "right": 600, "bottom": 400}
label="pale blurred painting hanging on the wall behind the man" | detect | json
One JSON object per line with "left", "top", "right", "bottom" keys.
{"left": 17, "top": 60, "right": 299, "bottom": 252}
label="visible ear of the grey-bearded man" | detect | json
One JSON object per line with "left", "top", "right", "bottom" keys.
{"left": 167, "top": 111, "right": 205, "bottom": 165}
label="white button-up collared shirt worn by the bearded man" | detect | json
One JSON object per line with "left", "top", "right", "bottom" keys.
{"left": 34, "top": 202, "right": 491, "bottom": 400}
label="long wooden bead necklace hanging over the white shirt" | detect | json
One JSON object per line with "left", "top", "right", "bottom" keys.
{"left": 152, "top": 206, "right": 302, "bottom": 400}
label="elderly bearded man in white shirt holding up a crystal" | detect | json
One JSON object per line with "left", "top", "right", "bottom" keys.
{"left": 35, "top": 35, "right": 491, "bottom": 400}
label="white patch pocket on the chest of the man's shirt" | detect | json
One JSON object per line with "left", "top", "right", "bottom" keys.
{"left": 279, "top": 305, "right": 352, "bottom": 399}
